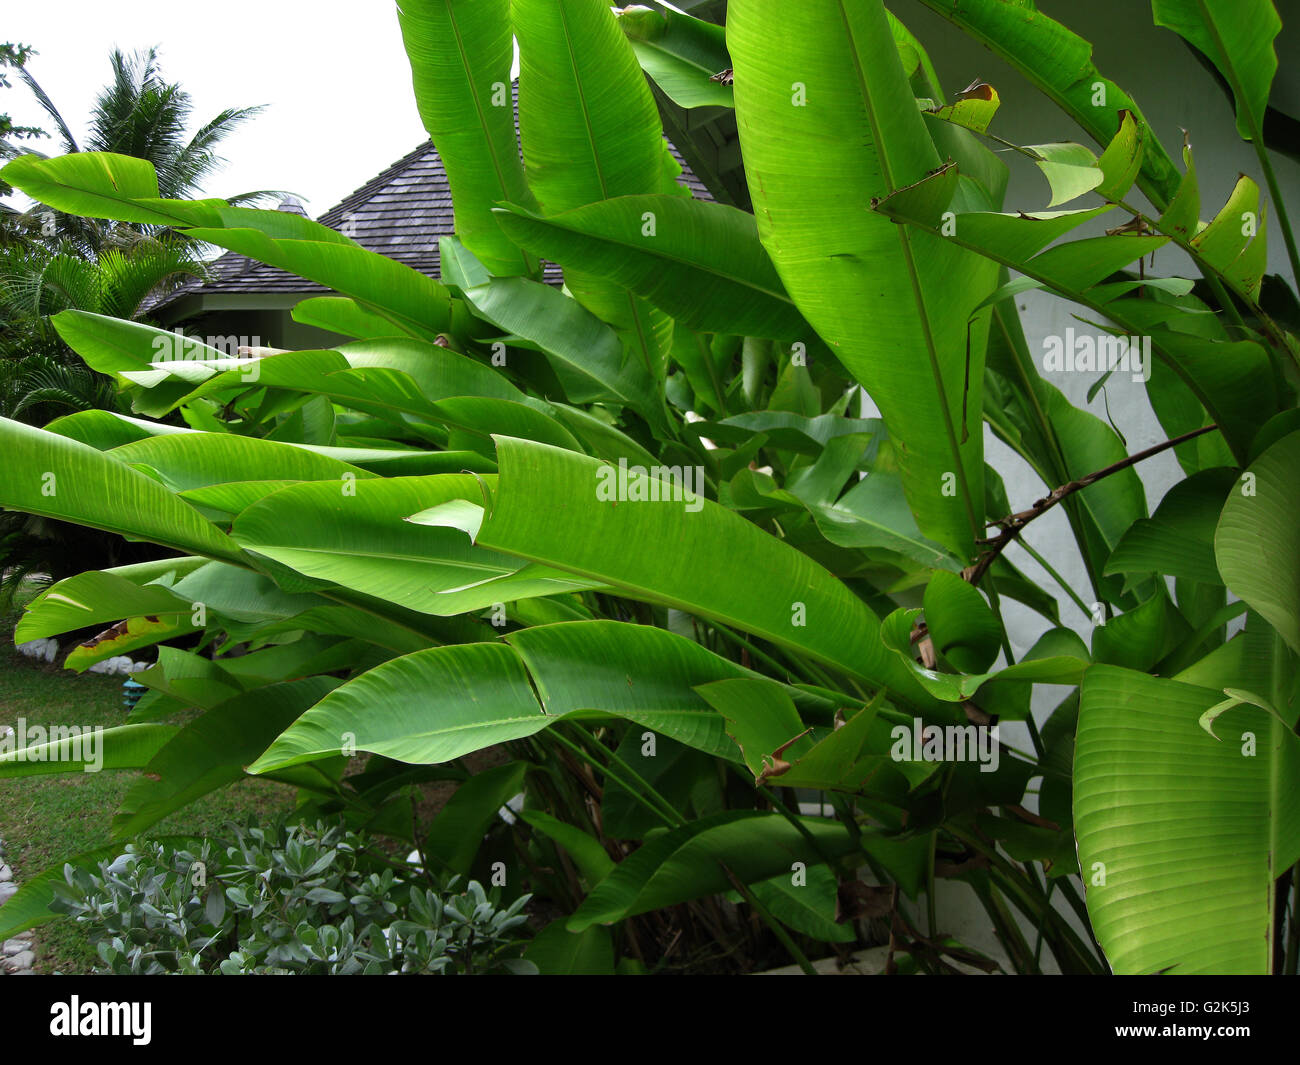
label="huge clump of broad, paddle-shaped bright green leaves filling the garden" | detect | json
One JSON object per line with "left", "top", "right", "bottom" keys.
{"left": 0, "top": 0, "right": 1300, "bottom": 973}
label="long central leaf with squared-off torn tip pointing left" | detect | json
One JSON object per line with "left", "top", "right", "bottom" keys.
{"left": 476, "top": 437, "right": 927, "bottom": 702}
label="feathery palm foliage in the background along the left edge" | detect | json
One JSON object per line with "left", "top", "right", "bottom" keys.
{"left": 0, "top": 46, "right": 276, "bottom": 603}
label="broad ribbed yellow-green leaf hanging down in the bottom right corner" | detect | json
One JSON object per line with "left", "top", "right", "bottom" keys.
{"left": 1074, "top": 666, "right": 1300, "bottom": 975}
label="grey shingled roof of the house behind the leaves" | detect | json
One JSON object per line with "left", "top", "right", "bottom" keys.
{"left": 147, "top": 140, "right": 712, "bottom": 313}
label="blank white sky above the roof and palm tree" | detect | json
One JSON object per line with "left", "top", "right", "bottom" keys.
{"left": 0, "top": 0, "right": 426, "bottom": 217}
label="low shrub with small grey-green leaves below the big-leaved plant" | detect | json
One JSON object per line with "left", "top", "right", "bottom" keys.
{"left": 53, "top": 821, "right": 536, "bottom": 977}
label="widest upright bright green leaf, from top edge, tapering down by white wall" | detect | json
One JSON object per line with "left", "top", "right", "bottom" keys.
{"left": 727, "top": 0, "right": 997, "bottom": 558}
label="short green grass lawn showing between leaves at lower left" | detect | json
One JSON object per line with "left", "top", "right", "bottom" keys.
{"left": 0, "top": 590, "right": 294, "bottom": 973}
